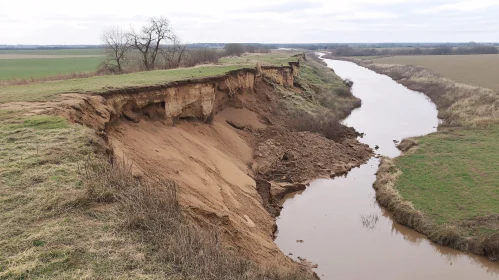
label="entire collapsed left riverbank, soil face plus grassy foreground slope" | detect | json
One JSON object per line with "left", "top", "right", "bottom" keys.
{"left": 0, "top": 53, "right": 371, "bottom": 279}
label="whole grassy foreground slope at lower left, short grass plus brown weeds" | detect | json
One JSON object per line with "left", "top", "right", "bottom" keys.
{"left": 0, "top": 111, "right": 309, "bottom": 279}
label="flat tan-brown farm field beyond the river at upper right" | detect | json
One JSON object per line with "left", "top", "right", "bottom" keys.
{"left": 373, "top": 54, "right": 499, "bottom": 90}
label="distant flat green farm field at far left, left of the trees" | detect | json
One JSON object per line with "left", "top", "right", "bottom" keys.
{"left": 0, "top": 49, "right": 104, "bottom": 81}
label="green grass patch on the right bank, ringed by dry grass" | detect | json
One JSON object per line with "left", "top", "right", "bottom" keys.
{"left": 395, "top": 127, "right": 499, "bottom": 228}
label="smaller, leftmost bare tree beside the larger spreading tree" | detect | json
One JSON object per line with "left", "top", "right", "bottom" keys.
{"left": 101, "top": 27, "right": 130, "bottom": 73}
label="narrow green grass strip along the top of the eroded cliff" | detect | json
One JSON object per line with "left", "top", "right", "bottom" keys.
{"left": 0, "top": 65, "right": 252, "bottom": 103}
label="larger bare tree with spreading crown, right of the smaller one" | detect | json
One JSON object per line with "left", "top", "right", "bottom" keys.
{"left": 128, "top": 17, "right": 173, "bottom": 70}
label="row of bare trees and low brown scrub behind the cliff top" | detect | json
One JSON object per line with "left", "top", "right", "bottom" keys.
{"left": 99, "top": 17, "right": 270, "bottom": 73}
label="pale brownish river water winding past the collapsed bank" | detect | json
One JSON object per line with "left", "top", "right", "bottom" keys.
{"left": 275, "top": 60, "right": 499, "bottom": 280}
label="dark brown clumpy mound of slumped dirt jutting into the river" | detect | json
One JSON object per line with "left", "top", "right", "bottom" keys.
{"left": 253, "top": 127, "right": 372, "bottom": 195}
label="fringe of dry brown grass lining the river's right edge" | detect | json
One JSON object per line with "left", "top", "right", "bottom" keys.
{"left": 325, "top": 56, "right": 499, "bottom": 261}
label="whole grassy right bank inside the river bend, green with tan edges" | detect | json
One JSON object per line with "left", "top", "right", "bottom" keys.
{"left": 357, "top": 58, "right": 499, "bottom": 260}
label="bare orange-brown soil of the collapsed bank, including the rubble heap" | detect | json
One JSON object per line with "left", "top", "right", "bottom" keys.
{"left": 2, "top": 63, "right": 372, "bottom": 274}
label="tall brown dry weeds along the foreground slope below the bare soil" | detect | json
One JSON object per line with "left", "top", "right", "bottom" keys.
{"left": 84, "top": 161, "right": 313, "bottom": 280}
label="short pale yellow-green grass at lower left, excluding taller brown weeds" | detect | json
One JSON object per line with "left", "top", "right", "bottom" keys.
{"left": 0, "top": 111, "right": 138, "bottom": 279}
